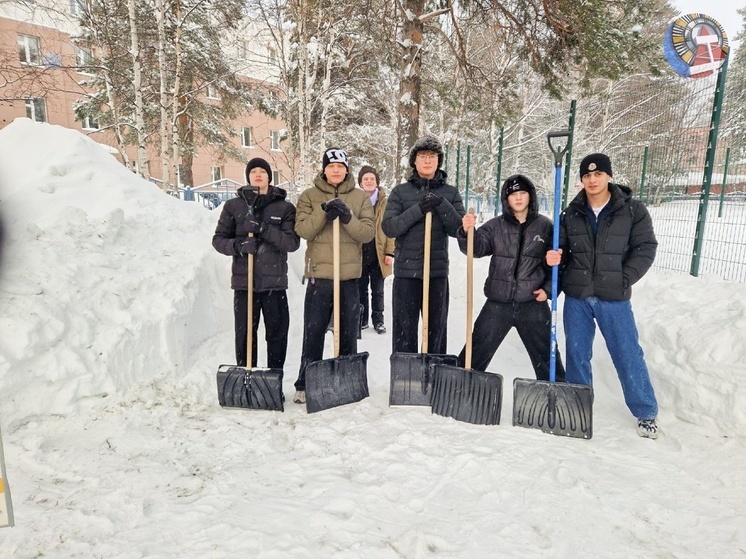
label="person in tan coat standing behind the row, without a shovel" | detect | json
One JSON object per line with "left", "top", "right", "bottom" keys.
{"left": 357, "top": 165, "right": 394, "bottom": 334}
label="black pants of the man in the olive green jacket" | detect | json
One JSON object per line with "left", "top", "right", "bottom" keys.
{"left": 295, "top": 279, "right": 360, "bottom": 390}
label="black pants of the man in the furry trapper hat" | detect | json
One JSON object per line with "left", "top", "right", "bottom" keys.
{"left": 392, "top": 277, "right": 448, "bottom": 354}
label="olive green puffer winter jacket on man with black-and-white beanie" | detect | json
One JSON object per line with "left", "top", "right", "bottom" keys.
{"left": 295, "top": 173, "right": 376, "bottom": 281}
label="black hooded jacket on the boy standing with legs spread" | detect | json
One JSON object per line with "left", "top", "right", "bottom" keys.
{"left": 458, "top": 181, "right": 552, "bottom": 303}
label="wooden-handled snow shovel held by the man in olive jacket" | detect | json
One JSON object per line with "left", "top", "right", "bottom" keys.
{"left": 306, "top": 217, "right": 369, "bottom": 413}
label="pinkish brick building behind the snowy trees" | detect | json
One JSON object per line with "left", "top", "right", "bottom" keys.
{"left": 0, "top": 0, "right": 293, "bottom": 196}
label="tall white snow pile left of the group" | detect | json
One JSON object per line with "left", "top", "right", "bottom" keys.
{"left": 0, "top": 119, "right": 228, "bottom": 428}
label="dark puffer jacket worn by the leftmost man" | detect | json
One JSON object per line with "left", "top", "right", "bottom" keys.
{"left": 212, "top": 186, "right": 300, "bottom": 291}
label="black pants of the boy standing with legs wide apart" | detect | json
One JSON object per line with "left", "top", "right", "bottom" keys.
{"left": 459, "top": 301, "right": 565, "bottom": 382}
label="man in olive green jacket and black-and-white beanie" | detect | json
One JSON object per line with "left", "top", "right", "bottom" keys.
{"left": 293, "top": 147, "right": 376, "bottom": 404}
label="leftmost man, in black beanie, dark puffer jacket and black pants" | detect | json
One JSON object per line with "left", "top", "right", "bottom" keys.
{"left": 212, "top": 157, "right": 300, "bottom": 369}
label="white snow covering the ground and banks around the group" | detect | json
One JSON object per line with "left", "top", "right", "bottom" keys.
{"left": 0, "top": 119, "right": 746, "bottom": 559}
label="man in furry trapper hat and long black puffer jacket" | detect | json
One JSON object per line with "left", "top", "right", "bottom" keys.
{"left": 381, "top": 136, "right": 465, "bottom": 354}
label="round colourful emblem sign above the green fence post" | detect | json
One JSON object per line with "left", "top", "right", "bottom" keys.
{"left": 663, "top": 14, "right": 730, "bottom": 78}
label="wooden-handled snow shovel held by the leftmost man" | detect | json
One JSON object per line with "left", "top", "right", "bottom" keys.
{"left": 217, "top": 226, "right": 285, "bottom": 411}
